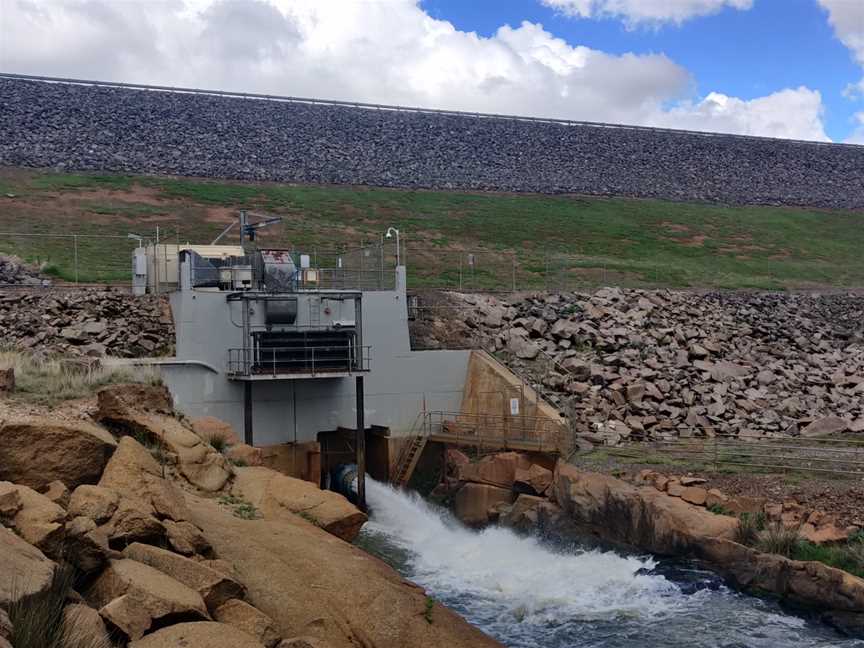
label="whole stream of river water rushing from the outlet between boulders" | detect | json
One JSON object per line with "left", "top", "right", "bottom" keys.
{"left": 359, "top": 480, "right": 864, "bottom": 648}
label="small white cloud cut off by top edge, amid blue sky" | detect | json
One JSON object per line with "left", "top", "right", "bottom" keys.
{"left": 540, "top": 0, "right": 753, "bottom": 27}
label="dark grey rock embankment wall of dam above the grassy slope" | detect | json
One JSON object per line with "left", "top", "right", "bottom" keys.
{"left": 0, "top": 77, "right": 864, "bottom": 209}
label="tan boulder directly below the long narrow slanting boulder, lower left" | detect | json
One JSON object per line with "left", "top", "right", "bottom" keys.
{"left": 86, "top": 559, "right": 210, "bottom": 645}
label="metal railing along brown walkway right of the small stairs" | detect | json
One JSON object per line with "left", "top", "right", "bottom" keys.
{"left": 423, "top": 411, "right": 574, "bottom": 456}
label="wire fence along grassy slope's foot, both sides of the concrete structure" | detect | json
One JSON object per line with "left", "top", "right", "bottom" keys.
{"left": 0, "top": 228, "right": 864, "bottom": 293}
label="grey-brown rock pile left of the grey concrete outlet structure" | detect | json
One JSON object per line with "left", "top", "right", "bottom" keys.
{"left": 0, "top": 290, "right": 174, "bottom": 358}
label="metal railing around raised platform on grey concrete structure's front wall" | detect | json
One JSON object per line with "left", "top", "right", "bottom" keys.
{"left": 228, "top": 345, "right": 372, "bottom": 378}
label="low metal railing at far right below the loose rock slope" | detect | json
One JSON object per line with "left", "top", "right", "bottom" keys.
{"left": 592, "top": 429, "right": 864, "bottom": 478}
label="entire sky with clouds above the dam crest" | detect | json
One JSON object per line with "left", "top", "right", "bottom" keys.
{"left": 0, "top": 0, "right": 864, "bottom": 144}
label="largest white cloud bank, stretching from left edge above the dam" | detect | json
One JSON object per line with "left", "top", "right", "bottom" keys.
{"left": 0, "top": 0, "right": 826, "bottom": 140}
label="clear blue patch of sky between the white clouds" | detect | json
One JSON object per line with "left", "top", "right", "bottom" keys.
{"left": 423, "top": 0, "right": 864, "bottom": 141}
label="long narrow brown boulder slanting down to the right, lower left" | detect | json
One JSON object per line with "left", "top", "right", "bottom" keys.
{"left": 123, "top": 542, "right": 245, "bottom": 612}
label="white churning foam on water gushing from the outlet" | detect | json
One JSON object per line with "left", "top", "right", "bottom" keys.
{"left": 367, "top": 482, "right": 684, "bottom": 622}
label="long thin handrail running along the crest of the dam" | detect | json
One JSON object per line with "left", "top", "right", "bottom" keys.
{"left": 0, "top": 71, "right": 861, "bottom": 148}
